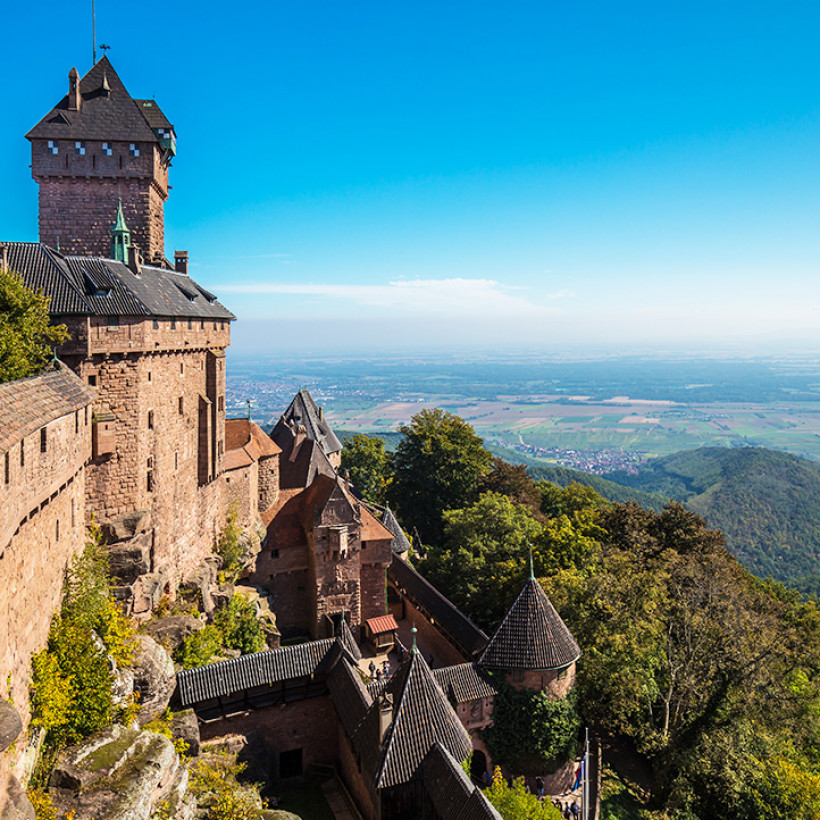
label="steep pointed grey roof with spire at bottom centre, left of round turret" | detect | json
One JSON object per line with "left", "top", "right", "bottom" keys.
{"left": 371, "top": 650, "right": 473, "bottom": 789}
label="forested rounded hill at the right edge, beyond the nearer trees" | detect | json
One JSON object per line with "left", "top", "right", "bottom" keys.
{"left": 607, "top": 447, "right": 820, "bottom": 592}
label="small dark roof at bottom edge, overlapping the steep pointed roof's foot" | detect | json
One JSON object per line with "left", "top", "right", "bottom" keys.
{"left": 422, "top": 742, "right": 501, "bottom": 820}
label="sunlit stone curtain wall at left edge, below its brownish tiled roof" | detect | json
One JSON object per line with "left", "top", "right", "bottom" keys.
{"left": 0, "top": 398, "right": 91, "bottom": 723}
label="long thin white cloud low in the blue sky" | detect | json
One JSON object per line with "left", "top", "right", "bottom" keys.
{"left": 219, "top": 278, "right": 573, "bottom": 316}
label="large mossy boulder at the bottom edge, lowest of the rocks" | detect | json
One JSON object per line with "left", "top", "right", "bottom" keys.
{"left": 49, "top": 725, "right": 181, "bottom": 820}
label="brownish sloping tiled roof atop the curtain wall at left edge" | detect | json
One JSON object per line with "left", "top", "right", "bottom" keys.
{"left": 0, "top": 362, "right": 97, "bottom": 452}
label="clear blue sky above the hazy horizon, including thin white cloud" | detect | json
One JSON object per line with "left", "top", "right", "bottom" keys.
{"left": 0, "top": 0, "right": 820, "bottom": 353}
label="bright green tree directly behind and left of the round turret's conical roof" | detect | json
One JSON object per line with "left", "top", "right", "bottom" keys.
{"left": 419, "top": 493, "right": 544, "bottom": 631}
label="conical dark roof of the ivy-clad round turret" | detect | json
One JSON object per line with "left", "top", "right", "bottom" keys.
{"left": 478, "top": 578, "right": 581, "bottom": 670}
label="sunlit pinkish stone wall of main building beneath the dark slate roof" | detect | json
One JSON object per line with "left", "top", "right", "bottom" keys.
{"left": 75, "top": 317, "right": 229, "bottom": 593}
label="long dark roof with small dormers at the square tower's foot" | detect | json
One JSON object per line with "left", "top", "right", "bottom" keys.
{"left": 6, "top": 242, "right": 236, "bottom": 320}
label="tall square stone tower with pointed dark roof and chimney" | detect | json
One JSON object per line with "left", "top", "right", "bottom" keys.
{"left": 26, "top": 57, "right": 176, "bottom": 263}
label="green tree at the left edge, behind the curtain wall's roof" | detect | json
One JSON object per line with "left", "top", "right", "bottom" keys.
{"left": 0, "top": 268, "right": 68, "bottom": 383}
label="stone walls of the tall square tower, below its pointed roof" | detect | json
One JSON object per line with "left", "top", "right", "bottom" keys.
{"left": 32, "top": 140, "right": 168, "bottom": 260}
